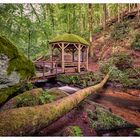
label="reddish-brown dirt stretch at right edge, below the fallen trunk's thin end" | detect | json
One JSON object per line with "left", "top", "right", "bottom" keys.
{"left": 94, "top": 88, "right": 140, "bottom": 127}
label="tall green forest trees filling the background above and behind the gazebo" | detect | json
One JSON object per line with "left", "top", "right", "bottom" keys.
{"left": 0, "top": 4, "right": 139, "bottom": 59}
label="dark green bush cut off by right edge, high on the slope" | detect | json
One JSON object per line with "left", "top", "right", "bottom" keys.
{"left": 131, "top": 34, "right": 140, "bottom": 50}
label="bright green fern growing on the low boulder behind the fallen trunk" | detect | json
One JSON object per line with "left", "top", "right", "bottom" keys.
{"left": 39, "top": 91, "right": 55, "bottom": 104}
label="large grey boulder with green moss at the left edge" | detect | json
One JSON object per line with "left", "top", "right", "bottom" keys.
{"left": 0, "top": 36, "right": 35, "bottom": 104}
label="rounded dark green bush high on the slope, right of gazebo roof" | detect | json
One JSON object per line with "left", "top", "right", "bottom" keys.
{"left": 110, "top": 22, "right": 129, "bottom": 40}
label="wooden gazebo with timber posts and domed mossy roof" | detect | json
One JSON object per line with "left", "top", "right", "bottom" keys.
{"left": 49, "top": 33, "right": 89, "bottom": 72}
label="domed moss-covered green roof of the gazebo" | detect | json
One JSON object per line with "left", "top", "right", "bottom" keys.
{"left": 49, "top": 33, "right": 89, "bottom": 46}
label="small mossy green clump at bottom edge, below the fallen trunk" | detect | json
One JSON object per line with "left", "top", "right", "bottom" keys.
{"left": 68, "top": 125, "right": 83, "bottom": 136}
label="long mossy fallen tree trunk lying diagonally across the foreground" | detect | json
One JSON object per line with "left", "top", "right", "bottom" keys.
{"left": 0, "top": 74, "right": 109, "bottom": 136}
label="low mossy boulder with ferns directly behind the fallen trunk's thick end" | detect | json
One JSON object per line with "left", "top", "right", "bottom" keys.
{"left": 0, "top": 88, "right": 67, "bottom": 111}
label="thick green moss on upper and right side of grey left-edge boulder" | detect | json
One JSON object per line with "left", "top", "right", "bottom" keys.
{"left": 0, "top": 37, "right": 35, "bottom": 80}
